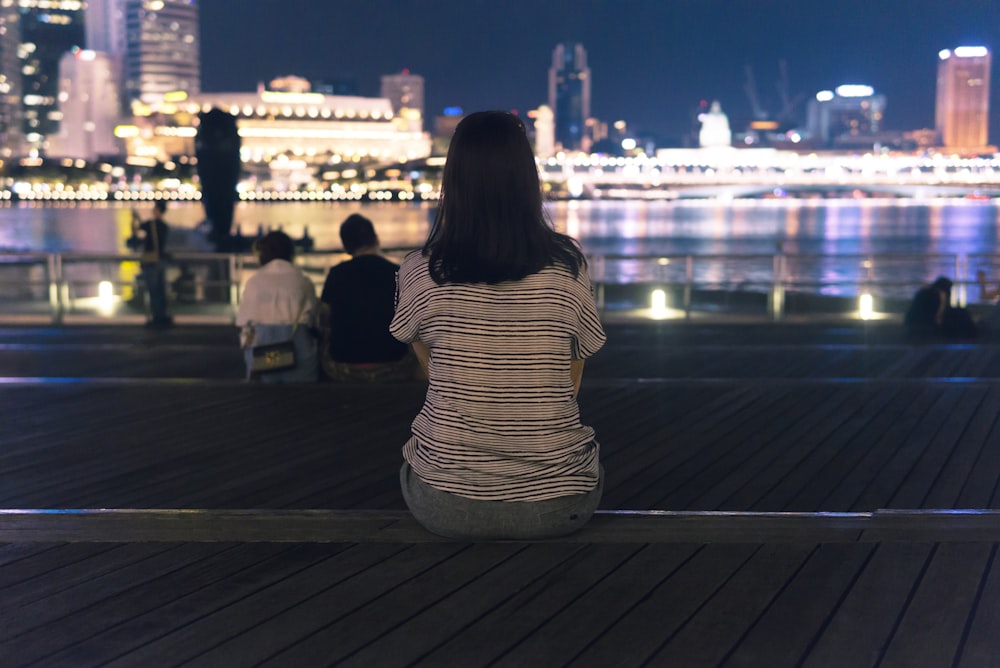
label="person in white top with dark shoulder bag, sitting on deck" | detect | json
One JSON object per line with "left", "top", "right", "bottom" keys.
{"left": 236, "top": 232, "right": 319, "bottom": 383}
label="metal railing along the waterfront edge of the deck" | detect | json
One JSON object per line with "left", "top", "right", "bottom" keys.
{"left": 0, "top": 248, "right": 1000, "bottom": 324}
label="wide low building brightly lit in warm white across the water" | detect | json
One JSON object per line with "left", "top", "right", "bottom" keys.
{"left": 116, "top": 90, "right": 431, "bottom": 177}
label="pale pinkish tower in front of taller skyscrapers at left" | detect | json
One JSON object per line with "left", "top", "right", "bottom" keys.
{"left": 48, "top": 49, "right": 121, "bottom": 160}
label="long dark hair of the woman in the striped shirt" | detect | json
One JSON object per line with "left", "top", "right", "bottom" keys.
{"left": 423, "top": 111, "right": 586, "bottom": 284}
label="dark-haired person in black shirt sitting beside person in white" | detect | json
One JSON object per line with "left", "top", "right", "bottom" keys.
{"left": 320, "top": 213, "right": 417, "bottom": 382}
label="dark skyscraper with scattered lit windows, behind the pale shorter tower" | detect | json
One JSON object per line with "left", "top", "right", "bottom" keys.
{"left": 16, "top": 0, "right": 85, "bottom": 152}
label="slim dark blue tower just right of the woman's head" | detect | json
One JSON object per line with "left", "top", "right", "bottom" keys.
{"left": 549, "top": 44, "right": 590, "bottom": 150}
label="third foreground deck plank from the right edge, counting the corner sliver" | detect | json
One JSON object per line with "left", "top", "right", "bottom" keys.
{"left": 802, "top": 543, "right": 933, "bottom": 668}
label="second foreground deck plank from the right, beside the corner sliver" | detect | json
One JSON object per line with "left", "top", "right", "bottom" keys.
{"left": 879, "top": 543, "right": 994, "bottom": 668}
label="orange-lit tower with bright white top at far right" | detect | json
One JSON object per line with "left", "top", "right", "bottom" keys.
{"left": 934, "top": 46, "right": 990, "bottom": 153}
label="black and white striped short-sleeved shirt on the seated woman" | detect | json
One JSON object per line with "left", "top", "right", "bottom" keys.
{"left": 389, "top": 251, "right": 605, "bottom": 501}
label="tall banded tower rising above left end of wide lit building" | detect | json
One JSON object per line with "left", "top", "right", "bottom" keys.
{"left": 124, "top": 0, "right": 201, "bottom": 102}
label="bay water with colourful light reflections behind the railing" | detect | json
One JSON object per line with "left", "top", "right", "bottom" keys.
{"left": 0, "top": 199, "right": 1000, "bottom": 294}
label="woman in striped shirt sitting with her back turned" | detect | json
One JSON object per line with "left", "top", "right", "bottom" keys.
{"left": 390, "top": 111, "right": 605, "bottom": 540}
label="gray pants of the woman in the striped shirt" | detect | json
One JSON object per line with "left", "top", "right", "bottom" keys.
{"left": 399, "top": 462, "right": 604, "bottom": 541}
